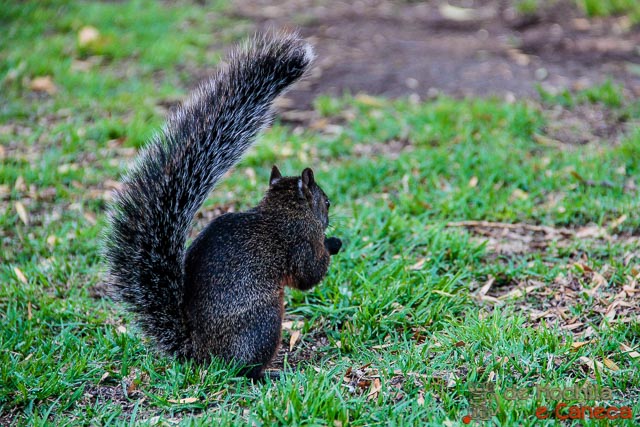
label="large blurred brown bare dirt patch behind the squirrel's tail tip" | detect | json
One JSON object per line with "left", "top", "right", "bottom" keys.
{"left": 233, "top": 0, "right": 640, "bottom": 108}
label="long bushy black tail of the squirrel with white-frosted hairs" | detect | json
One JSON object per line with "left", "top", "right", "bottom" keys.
{"left": 104, "top": 35, "right": 314, "bottom": 357}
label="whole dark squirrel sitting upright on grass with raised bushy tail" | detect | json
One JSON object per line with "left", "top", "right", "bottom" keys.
{"left": 103, "top": 34, "right": 342, "bottom": 379}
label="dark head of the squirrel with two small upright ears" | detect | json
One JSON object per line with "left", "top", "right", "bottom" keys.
{"left": 266, "top": 166, "right": 331, "bottom": 229}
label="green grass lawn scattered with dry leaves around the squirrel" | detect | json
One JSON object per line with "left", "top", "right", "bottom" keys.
{"left": 0, "top": 1, "right": 640, "bottom": 426}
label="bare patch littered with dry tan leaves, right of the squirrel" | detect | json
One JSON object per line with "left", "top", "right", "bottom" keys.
{"left": 448, "top": 221, "right": 640, "bottom": 341}
